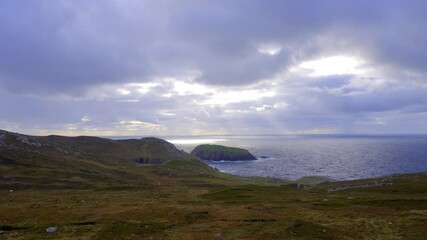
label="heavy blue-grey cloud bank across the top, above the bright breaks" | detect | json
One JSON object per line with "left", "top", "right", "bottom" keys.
{"left": 0, "top": 1, "right": 427, "bottom": 94}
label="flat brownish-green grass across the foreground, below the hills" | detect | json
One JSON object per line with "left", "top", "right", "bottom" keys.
{"left": 0, "top": 173, "right": 427, "bottom": 239}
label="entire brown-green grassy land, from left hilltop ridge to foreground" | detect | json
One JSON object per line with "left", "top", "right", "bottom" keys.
{"left": 0, "top": 132, "right": 427, "bottom": 239}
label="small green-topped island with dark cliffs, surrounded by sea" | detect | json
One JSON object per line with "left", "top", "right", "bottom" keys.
{"left": 191, "top": 144, "right": 257, "bottom": 161}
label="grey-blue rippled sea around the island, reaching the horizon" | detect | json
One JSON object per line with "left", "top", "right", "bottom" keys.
{"left": 165, "top": 135, "right": 427, "bottom": 180}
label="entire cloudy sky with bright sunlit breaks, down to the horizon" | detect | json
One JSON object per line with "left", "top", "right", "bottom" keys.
{"left": 0, "top": 0, "right": 427, "bottom": 136}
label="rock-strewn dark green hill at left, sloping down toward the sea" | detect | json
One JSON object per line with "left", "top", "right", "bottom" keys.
{"left": 0, "top": 131, "right": 280, "bottom": 189}
